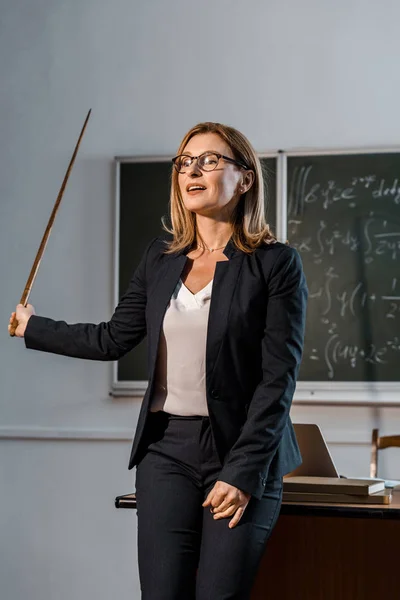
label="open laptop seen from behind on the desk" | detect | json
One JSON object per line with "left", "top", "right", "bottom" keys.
{"left": 286, "top": 423, "right": 340, "bottom": 477}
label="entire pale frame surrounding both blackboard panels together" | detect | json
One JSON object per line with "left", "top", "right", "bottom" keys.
{"left": 111, "top": 147, "right": 400, "bottom": 406}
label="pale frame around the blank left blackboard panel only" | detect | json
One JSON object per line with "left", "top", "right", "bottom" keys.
{"left": 110, "top": 151, "right": 280, "bottom": 397}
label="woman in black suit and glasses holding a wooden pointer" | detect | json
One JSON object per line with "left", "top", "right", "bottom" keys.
{"left": 10, "top": 123, "right": 307, "bottom": 600}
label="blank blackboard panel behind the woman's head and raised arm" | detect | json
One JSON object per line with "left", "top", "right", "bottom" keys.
{"left": 113, "top": 156, "right": 277, "bottom": 392}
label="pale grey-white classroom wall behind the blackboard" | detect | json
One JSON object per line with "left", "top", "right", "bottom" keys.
{"left": 0, "top": 0, "right": 400, "bottom": 600}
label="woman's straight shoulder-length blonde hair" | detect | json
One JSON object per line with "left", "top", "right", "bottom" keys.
{"left": 162, "top": 122, "right": 276, "bottom": 254}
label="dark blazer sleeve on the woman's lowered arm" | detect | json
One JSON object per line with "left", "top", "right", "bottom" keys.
{"left": 218, "top": 246, "right": 308, "bottom": 498}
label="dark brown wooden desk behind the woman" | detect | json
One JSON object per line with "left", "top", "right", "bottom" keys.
{"left": 116, "top": 491, "right": 400, "bottom": 600}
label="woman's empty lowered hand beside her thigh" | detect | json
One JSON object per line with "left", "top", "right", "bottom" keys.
{"left": 203, "top": 481, "right": 251, "bottom": 528}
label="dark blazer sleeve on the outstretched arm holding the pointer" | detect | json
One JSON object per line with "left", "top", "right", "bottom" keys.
{"left": 24, "top": 238, "right": 157, "bottom": 360}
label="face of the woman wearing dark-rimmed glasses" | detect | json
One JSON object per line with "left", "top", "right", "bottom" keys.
{"left": 178, "top": 133, "right": 248, "bottom": 217}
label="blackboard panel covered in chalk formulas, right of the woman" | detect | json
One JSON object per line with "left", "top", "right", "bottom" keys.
{"left": 287, "top": 152, "right": 400, "bottom": 382}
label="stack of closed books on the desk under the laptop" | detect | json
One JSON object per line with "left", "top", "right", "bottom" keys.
{"left": 283, "top": 476, "right": 392, "bottom": 504}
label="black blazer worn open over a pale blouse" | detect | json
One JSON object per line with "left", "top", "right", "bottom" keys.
{"left": 25, "top": 238, "right": 307, "bottom": 498}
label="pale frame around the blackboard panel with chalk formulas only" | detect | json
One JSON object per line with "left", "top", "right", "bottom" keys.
{"left": 284, "top": 146, "right": 400, "bottom": 407}
